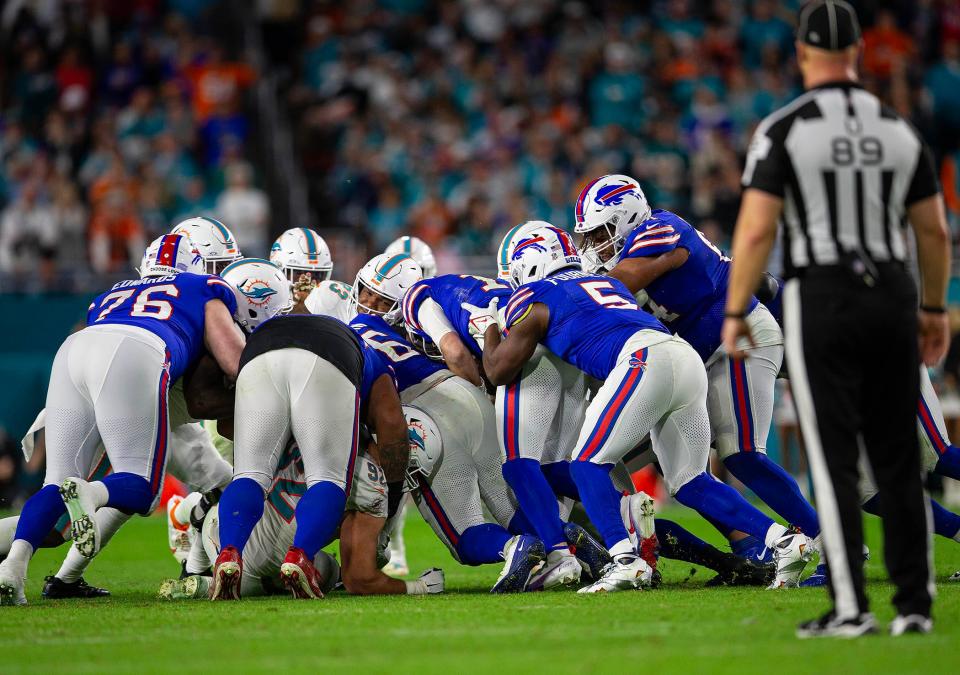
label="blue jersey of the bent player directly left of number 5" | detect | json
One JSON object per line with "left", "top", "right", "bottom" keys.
{"left": 403, "top": 274, "right": 511, "bottom": 357}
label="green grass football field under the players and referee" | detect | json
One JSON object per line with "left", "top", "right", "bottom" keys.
{"left": 0, "top": 509, "right": 960, "bottom": 675}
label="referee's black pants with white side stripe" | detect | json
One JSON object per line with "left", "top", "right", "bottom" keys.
{"left": 784, "top": 265, "right": 933, "bottom": 618}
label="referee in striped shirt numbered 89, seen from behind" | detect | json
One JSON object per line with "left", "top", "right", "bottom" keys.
{"left": 723, "top": 0, "right": 950, "bottom": 637}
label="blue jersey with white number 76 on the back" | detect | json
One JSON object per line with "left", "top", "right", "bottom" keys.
{"left": 87, "top": 273, "right": 237, "bottom": 380}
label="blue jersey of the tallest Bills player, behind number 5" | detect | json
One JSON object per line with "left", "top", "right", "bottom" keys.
{"left": 620, "top": 209, "right": 757, "bottom": 361}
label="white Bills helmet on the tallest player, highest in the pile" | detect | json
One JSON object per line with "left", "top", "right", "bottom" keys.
{"left": 573, "top": 174, "right": 651, "bottom": 273}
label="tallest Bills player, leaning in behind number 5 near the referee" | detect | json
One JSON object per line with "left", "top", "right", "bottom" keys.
{"left": 574, "top": 175, "right": 820, "bottom": 572}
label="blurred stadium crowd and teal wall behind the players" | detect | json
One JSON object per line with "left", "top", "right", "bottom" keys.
{"left": 0, "top": 0, "right": 960, "bottom": 508}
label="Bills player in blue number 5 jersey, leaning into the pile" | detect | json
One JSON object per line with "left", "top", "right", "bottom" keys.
{"left": 483, "top": 227, "right": 810, "bottom": 593}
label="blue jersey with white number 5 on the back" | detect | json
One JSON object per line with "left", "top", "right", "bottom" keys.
{"left": 506, "top": 270, "right": 669, "bottom": 380}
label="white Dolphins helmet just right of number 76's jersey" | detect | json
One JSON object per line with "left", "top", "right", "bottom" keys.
{"left": 220, "top": 258, "right": 293, "bottom": 333}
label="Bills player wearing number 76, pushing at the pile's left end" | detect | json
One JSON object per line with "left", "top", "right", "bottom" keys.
{"left": 0, "top": 235, "right": 244, "bottom": 604}
